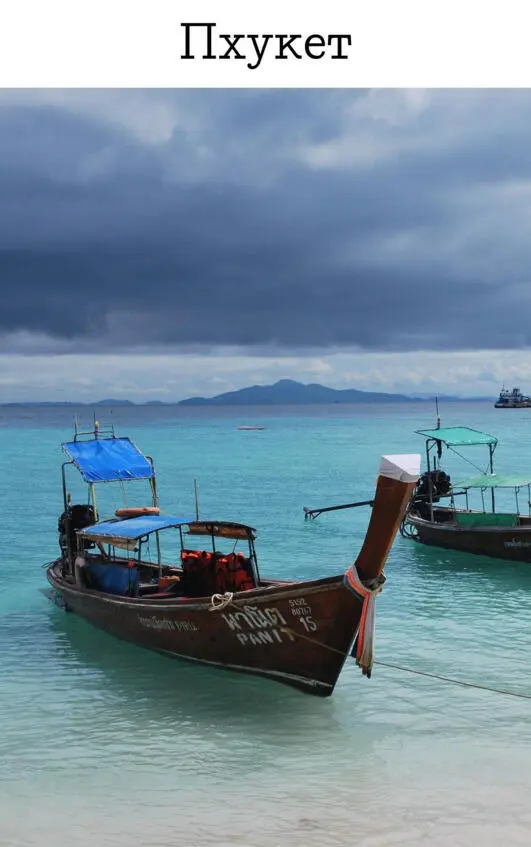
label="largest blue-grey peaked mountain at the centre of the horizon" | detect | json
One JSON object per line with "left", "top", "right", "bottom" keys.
{"left": 178, "top": 379, "right": 418, "bottom": 406}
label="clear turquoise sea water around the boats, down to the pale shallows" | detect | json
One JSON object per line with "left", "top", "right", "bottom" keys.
{"left": 0, "top": 403, "right": 531, "bottom": 847}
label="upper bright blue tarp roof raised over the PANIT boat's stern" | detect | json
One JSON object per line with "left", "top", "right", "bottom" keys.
{"left": 63, "top": 438, "right": 153, "bottom": 482}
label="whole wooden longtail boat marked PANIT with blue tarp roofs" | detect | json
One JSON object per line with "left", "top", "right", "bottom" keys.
{"left": 47, "top": 428, "right": 420, "bottom": 697}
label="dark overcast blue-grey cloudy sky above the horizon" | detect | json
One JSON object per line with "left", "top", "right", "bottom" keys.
{"left": 0, "top": 90, "right": 531, "bottom": 402}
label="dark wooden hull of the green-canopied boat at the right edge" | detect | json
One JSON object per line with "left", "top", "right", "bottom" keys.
{"left": 407, "top": 514, "right": 531, "bottom": 562}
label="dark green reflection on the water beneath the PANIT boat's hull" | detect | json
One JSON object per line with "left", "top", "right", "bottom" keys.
{"left": 44, "top": 606, "right": 340, "bottom": 740}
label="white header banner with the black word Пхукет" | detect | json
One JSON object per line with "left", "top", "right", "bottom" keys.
{"left": 0, "top": 0, "right": 531, "bottom": 88}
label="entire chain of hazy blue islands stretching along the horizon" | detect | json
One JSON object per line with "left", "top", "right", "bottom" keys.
{"left": 3, "top": 379, "right": 492, "bottom": 406}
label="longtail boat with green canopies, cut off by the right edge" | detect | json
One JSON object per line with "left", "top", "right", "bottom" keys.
{"left": 400, "top": 426, "right": 531, "bottom": 562}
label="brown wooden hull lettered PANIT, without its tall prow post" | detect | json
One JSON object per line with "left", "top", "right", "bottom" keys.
{"left": 47, "top": 563, "right": 362, "bottom": 697}
